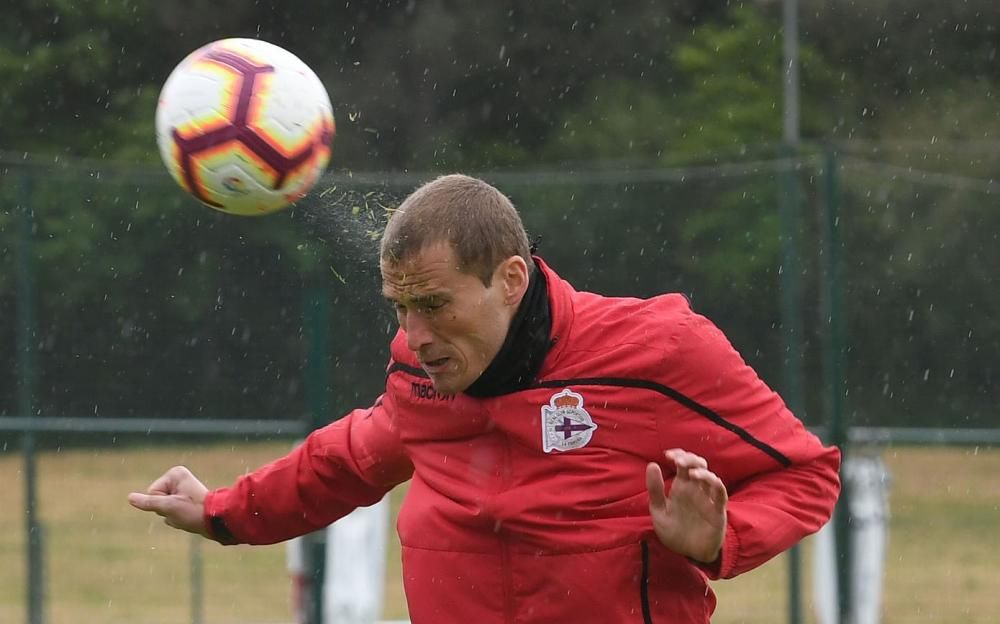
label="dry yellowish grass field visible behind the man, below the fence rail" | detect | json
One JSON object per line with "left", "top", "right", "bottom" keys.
{"left": 0, "top": 442, "right": 1000, "bottom": 624}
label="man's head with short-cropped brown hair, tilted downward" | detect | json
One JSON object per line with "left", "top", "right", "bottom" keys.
{"left": 380, "top": 175, "right": 533, "bottom": 394}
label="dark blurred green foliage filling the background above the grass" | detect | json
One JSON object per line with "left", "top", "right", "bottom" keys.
{"left": 7, "top": 0, "right": 1000, "bottom": 426}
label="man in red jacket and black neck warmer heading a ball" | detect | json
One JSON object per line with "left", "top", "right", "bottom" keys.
{"left": 129, "top": 175, "right": 840, "bottom": 624}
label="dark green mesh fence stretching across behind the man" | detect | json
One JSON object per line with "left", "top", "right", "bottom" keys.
{"left": 0, "top": 144, "right": 1000, "bottom": 624}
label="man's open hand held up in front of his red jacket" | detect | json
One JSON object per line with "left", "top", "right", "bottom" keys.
{"left": 646, "top": 449, "right": 729, "bottom": 563}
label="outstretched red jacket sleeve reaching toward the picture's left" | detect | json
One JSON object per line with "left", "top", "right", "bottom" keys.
{"left": 205, "top": 395, "right": 413, "bottom": 544}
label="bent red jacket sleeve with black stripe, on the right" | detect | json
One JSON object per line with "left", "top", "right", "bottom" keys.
{"left": 677, "top": 315, "right": 840, "bottom": 579}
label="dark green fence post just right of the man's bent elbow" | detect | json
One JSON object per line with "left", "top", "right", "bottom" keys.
{"left": 819, "top": 147, "right": 853, "bottom": 623}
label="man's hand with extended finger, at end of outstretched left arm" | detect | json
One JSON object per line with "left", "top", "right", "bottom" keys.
{"left": 128, "top": 466, "right": 209, "bottom": 537}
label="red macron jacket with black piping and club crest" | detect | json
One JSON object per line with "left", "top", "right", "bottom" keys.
{"left": 205, "top": 262, "right": 840, "bottom": 624}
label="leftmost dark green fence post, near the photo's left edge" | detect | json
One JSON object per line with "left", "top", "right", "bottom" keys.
{"left": 16, "top": 171, "right": 45, "bottom": 624}
